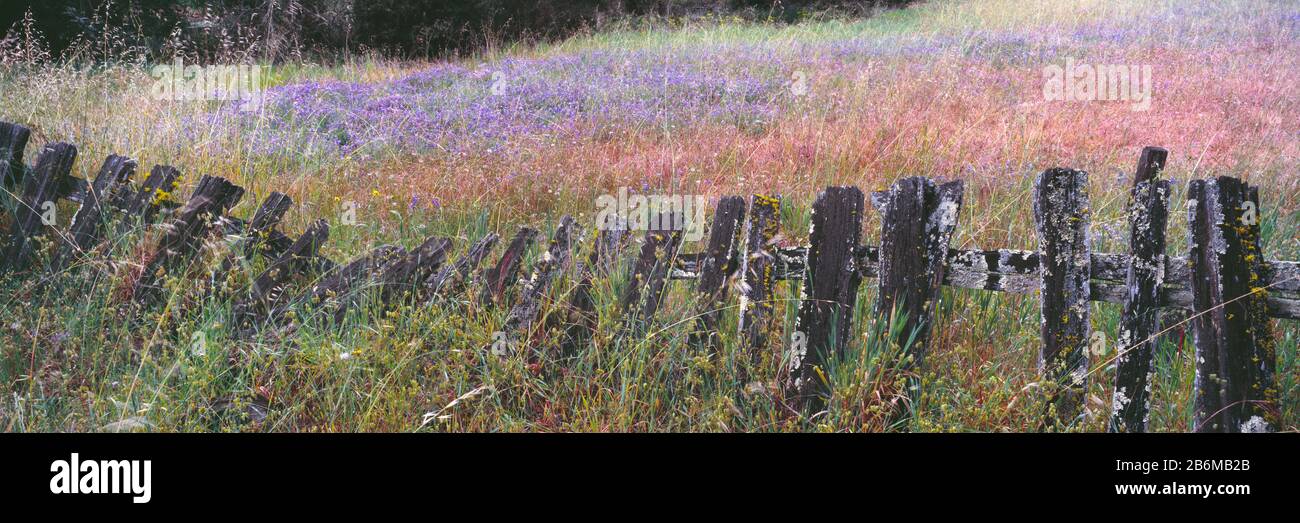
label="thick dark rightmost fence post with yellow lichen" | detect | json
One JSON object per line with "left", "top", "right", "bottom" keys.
{"left": 1187, "top": 176, "right": 1278, "bottom": 432}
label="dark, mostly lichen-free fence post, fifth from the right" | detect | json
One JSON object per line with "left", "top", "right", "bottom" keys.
{"left": 785, "top": 187, "right": 865, "bottom": 410}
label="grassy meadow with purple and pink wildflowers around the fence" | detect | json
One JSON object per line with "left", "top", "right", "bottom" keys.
{"left": 0, "top": 0, "right": 1300, "bottom": 432}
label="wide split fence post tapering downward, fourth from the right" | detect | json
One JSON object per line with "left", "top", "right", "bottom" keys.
{"left": 876, "top": 177, "right": 962, "bottom": 374}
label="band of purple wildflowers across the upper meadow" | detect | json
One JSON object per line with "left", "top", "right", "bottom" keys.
{"left": 195, "top": 7, "right": 1296, "bottom": 159}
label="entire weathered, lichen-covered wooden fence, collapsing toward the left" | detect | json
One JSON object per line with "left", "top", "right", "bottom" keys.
{"left": 0, "top": 122, "right": 1300, "bottom": 432}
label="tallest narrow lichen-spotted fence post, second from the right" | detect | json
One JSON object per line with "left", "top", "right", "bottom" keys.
{"left": 1108, "top": 147, "right": 1169, "bottom": 432}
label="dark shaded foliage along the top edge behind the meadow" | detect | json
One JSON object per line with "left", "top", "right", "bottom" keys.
{"left": 0, "top": 0, "right": 911, "bottom": 60}
